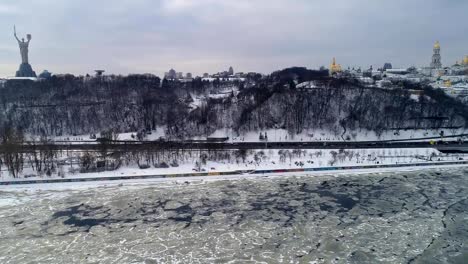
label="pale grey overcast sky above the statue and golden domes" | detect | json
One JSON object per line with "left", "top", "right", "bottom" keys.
{"left": 0, "top": 0, "right": 468, "bottom": 77}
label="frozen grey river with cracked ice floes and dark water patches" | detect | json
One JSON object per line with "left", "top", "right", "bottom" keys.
{"left": 0, "top": 168, "right": 468, "bottom": 264}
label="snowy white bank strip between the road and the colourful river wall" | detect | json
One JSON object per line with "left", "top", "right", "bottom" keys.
{"left": 0, "top": 146, "right": 468, "bottom": 181}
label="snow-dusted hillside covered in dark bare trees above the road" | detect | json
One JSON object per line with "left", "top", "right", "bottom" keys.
{"left": 0, "top": 68, "right": 468, "bottom": 139}
